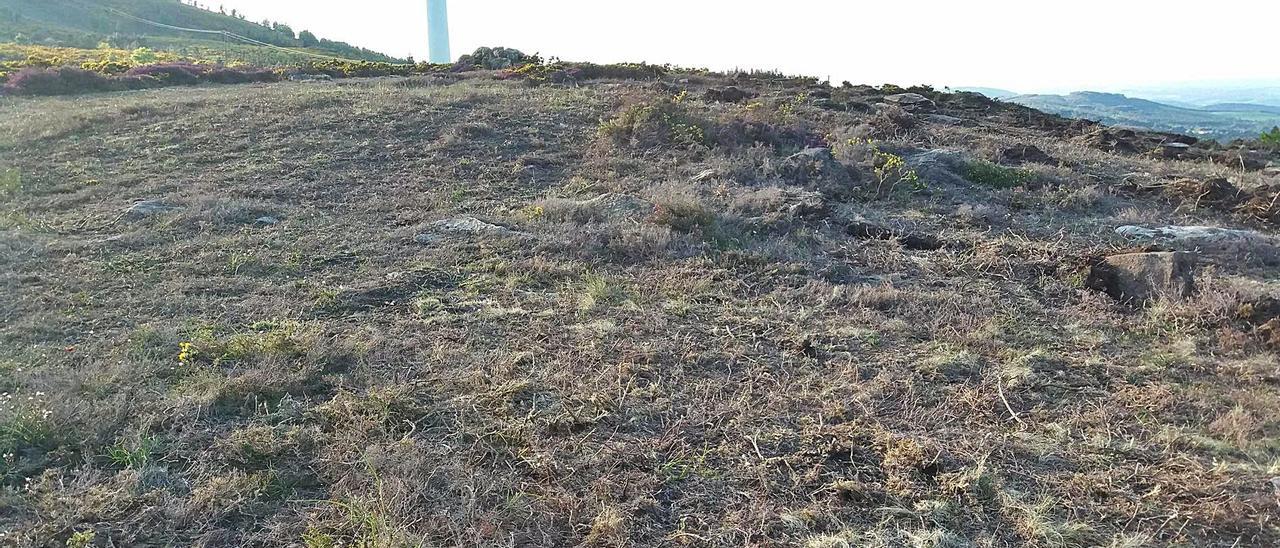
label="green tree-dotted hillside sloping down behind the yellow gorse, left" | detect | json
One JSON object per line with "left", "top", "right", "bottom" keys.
{"left": 0, "top": 0, "right": 397, "bottom": 64}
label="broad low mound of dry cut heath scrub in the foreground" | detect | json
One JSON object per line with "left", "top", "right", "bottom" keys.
{"left": 0, "top": 74, "right": 1280, "bottom": 547}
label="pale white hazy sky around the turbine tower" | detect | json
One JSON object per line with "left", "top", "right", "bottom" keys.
{"left": 212, "top": 0, "right": 1280, "bottom": 92}
